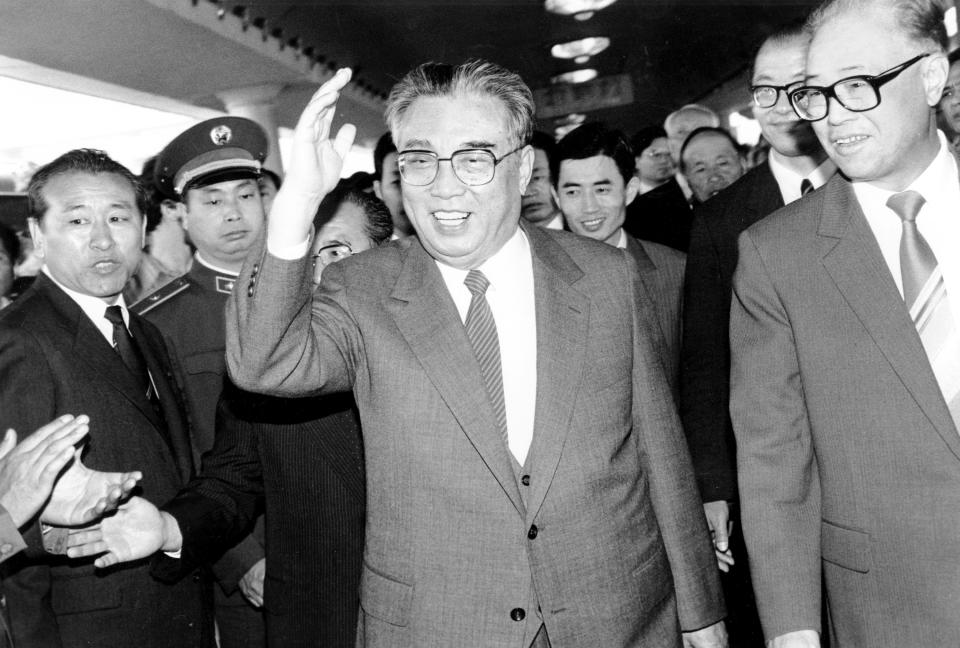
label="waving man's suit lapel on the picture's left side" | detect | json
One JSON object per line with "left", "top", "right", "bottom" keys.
{"left": 387, "top": 242, "right": 525, "bottom": 515}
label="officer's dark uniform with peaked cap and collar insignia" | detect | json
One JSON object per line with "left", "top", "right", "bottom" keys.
{"left": 131, "top": 117, "right": 267, "bottom": 648}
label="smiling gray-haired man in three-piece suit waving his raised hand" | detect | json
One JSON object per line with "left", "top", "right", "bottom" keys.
{"left": 218, "top": 61, "right": 726, "bottom": 648}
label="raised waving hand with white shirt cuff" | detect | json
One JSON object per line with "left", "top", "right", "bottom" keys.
{"left": 267, "top": 68, "right": 357, "bottom": 248}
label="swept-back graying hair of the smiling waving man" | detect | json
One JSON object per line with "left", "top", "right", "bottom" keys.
{"left": 384, "top": 59, "right": 534, "bottom": 146}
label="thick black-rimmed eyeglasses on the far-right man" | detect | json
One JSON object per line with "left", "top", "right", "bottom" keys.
{"left": 789, "top": 52, "right": 931, "bottom": 121}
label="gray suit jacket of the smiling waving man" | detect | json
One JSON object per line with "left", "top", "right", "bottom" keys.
{"left": 227, "top": 227, "right": 723, "bottom": 648}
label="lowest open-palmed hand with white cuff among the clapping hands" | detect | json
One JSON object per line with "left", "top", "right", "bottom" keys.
{"left": 67, "top": 497, "right": 181, "bottom": 568}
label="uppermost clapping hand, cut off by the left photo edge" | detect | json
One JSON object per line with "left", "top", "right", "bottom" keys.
{"left": 0, "top": 414, "right": 90, "bottom": 527}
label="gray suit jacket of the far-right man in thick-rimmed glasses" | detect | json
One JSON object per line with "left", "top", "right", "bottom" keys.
{"left": 730, "top": 175, "right": 960, "bottom": 648}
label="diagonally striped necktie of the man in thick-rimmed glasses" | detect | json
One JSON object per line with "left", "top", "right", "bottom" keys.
{"left": 887, "top": 191, "right": 960, "bottom": 430}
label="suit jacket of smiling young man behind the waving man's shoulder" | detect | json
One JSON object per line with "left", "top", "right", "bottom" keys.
{"left": 627, "top": 234, "right": 686, "bottom": 396}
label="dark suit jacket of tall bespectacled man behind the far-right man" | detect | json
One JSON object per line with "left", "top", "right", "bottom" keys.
{"left": 680, "top": 162, "right": 783, "bottom": 502}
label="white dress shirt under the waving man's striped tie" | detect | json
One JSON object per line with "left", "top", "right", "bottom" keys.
{"left": 436, "top": 228, "right": 537, "bottom": 466}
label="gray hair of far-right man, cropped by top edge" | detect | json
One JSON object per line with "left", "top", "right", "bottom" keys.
{"left": 807, "top": 0, "right": 950, "bottom": 52}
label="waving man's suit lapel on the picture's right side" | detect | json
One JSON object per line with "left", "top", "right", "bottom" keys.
{"left": 524, "top": 227, "right": 590, "bottom": 521}
